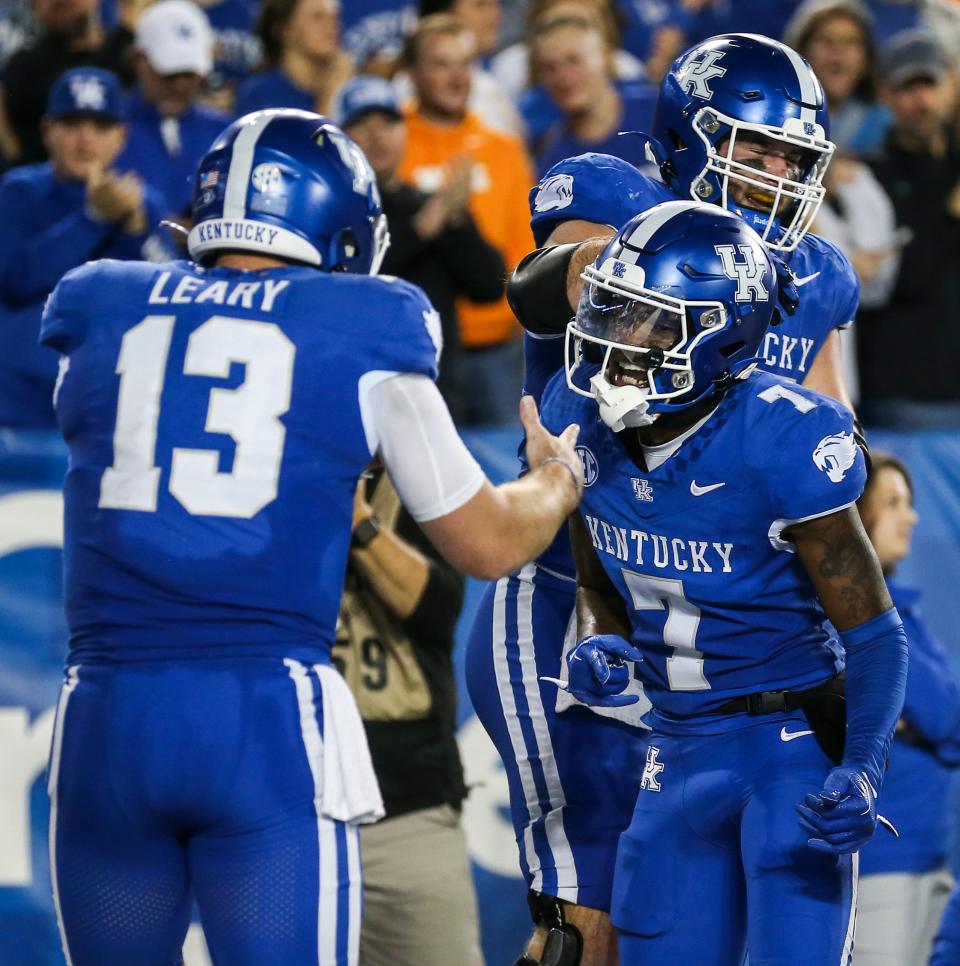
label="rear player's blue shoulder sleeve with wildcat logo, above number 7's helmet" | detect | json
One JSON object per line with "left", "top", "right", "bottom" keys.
{"left": 530, "top": 154, "right": 675, "bottom": 245}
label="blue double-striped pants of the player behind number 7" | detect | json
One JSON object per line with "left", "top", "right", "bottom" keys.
{"left": 466, "top": 564, "right": 644, "bottom": 911}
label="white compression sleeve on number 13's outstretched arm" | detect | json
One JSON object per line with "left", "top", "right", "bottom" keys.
{"left": 360, "top": 373, "right": 486, "bottom": 523}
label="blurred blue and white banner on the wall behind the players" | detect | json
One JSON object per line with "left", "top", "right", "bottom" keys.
{"left": 0, "top": 429, "right": 960, "bottom": 966}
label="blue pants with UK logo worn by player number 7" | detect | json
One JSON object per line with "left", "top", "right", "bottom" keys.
{"left": 611, "top": 713, "right": 856, "bottom": 966}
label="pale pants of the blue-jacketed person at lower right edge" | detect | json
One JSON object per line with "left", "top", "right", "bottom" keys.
{"left": 853, "top": 869, "right": 953, "bottom": 966}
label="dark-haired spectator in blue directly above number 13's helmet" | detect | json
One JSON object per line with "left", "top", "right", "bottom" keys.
{"left": 235, "top": 0, "right": 353, "bottom": 114}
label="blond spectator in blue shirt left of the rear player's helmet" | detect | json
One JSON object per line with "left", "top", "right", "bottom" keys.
{"left": 531, "top": 12, "right": 657, "bottom": 177}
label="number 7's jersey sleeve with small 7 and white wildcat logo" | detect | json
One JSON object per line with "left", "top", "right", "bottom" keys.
{"left": 754, "top": 380, "right": 867, "bottom": 549}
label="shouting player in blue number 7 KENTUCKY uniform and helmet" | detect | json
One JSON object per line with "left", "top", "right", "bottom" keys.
{"left": 542, "top": 201, "right": 907, "bottom": 966}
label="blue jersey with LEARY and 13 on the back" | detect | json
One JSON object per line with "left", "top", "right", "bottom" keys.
{"left": 41, "top": 261, "right": 439, "bottom": 660}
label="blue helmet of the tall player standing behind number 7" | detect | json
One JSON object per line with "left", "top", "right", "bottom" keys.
{"left": 648, "top": 34, "right": 835, "bottom": 252}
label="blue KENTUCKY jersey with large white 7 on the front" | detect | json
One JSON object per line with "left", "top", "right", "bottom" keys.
{"left": 543, "top": 371, "right": 865, "bottom": 715}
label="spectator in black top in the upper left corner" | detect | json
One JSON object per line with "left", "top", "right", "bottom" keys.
{"left": 0, "top": 0, "right": 132, "bottom": 165}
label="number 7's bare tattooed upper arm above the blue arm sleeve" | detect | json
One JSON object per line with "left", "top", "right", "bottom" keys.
{"left": 788, "top": 507, "right": 893, "bottom": 631}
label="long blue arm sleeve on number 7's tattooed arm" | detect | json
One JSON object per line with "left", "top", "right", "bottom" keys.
{"left": 840, "top": 607, "right": 907, "bottom": 792}
